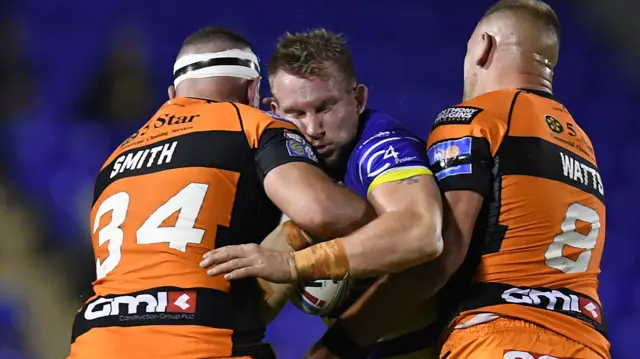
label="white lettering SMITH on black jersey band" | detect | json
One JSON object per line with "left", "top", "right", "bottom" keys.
{"left": 109, "top": 141, "right": 178, "bottom": 178}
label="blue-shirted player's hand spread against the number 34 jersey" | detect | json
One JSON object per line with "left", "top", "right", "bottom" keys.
{"left": 200, "top": 244, "right": 297, "bottom": 283}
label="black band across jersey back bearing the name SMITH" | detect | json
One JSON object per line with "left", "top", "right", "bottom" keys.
{"left": 93, "top": 131, "right": 253, "bottom": 203}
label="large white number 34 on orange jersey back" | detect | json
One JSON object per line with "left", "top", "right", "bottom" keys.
{"left": 93, "top": 183, "right": 209, "bottom": 279}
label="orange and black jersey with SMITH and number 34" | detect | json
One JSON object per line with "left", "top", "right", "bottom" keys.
{"left": 70, "top": 98, "right": 317, "bottom": 359}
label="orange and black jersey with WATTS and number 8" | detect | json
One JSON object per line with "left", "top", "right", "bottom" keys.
{"left": 427, "top": 90, "right": 609, "bottom": 358}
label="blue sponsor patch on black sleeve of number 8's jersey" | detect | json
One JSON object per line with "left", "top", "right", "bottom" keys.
{"left": 427, "top": 137, "right": 472, "bottom": 180}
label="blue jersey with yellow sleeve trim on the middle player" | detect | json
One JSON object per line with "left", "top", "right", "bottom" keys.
{"left": 325, "top": 110, "right": 439, "bottom": 359}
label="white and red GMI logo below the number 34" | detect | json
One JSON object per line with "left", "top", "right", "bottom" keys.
{"left": 84, "top": 291, "right": 196, "bottom": 321}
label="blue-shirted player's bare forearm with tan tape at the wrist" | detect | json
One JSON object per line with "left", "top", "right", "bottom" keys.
{"left": 294, "top": 211, "right": 442, "bottom": 279}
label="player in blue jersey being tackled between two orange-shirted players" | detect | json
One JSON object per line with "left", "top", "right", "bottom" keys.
{"left": 204, "top": 30, "right": 442, "bottom": 358}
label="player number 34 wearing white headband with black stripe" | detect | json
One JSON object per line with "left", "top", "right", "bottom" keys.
{"left": 69, "top": 28, "right": 375, "bottom": 359}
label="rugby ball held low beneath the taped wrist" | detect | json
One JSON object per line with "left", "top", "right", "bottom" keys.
{"left": 290, "top": 279, "right": 349, "bottom": 317}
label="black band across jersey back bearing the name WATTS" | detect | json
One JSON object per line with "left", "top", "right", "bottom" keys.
{"left": 500, "top": 136, "right": 604, "bottom": 203}
